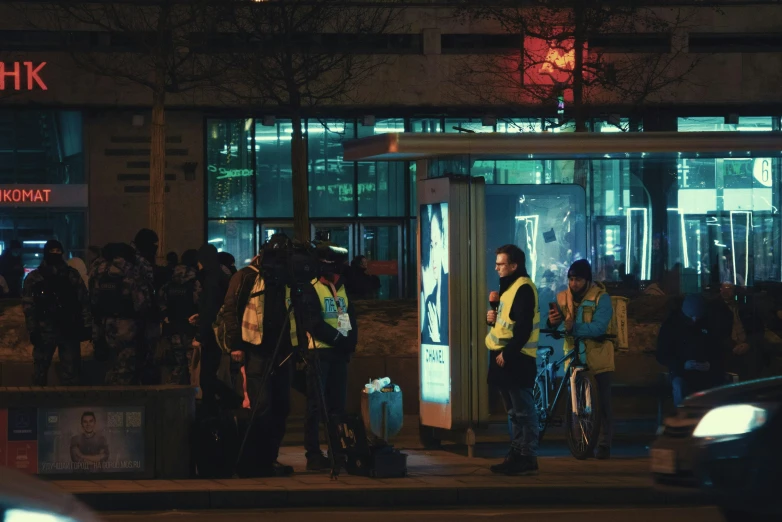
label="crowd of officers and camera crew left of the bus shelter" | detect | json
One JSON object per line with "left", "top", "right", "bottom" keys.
{"left": 13, "top": 229, "right": 388, "bottom": 476}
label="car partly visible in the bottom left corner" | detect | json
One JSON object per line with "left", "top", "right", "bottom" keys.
{"left": 0, "top": 467, "right": 100, "bottom": 522}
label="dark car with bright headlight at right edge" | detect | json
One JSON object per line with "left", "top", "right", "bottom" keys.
{"left": 650, "top": 377, "right": 782, "bottom": 522}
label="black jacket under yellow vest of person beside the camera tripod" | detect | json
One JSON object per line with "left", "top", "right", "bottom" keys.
{"left": 302, "top": 277, "right": 358, "bottom": 360}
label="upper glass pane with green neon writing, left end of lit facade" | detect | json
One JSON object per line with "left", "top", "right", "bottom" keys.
{"left": 206, "top": 119, "right": 255, "bottom": 217}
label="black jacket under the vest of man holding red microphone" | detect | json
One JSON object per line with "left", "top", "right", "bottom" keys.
{"left": 488, "top": 271, "right": 537, "bottom": 388}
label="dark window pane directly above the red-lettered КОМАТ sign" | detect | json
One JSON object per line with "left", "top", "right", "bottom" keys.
{"left": 0, "top": 109, "right": 85, "bottom": 184}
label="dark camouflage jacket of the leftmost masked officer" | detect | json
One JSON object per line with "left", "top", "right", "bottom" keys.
{"left": 22, "top": 261, "right": 92, "bottom": 333}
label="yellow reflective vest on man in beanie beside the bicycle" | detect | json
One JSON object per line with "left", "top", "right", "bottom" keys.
{"left": 557, "top": 282, "right": 614, "bottom": 375}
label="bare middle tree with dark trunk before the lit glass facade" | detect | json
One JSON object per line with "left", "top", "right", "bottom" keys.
{"left": 221, "top": 0, "right": 402, "bottom": 240}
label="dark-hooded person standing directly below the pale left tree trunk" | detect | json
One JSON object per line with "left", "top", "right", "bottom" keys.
{"left": 133, "top": 228, "right": 166, "bottom": 385}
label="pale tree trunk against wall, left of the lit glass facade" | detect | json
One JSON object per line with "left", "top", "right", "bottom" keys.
{"left": 149, "top": 90, "right": 166, "bottom": 263}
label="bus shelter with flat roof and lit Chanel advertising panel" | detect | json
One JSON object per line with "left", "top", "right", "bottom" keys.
{"left": 344, "top": 132, "right": 782, "bottom": 454}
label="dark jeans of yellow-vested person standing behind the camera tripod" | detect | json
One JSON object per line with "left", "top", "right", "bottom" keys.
{"left": 304, "top": 359, "right": 348, "bottom": 458}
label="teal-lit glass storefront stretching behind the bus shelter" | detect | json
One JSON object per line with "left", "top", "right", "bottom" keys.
{"left": 206, "top": 116, "right": 782, "bottom": 298}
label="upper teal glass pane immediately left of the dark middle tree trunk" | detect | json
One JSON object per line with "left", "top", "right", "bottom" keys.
{"left": 255, "top": 120, "right": 293, "bottom": 218}
